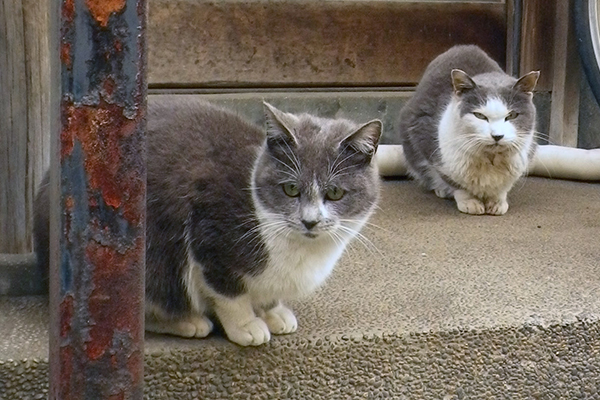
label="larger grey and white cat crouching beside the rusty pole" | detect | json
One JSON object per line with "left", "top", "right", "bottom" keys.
{"left": 36, "top": 96, "right": 382, "bottom": 346}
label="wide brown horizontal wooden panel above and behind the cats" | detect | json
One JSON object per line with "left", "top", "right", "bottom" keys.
{"left": 148, "top": 0, "right": 506, "bottom": 87}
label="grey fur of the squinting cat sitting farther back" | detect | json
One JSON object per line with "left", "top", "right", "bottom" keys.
{"left": 399, "top": 45, "right": 539, "bottom": 211}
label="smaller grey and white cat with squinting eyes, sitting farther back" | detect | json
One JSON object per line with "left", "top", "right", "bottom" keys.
{"left": 399, "top": 46, "right": 539, "bottom": 215}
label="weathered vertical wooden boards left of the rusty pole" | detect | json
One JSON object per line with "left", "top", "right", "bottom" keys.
{"left": 0, "top": 0, "right": 50, "bottom": 253}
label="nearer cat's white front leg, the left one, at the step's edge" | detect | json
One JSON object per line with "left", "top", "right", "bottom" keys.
{"left": 213, "top": 295, "right": 271, "bottom": 346}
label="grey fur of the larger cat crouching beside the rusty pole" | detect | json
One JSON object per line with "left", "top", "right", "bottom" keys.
{"left": 36, "top": 96, "right": 381, "bottom": 345}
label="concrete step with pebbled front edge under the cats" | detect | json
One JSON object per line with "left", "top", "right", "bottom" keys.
{"left": 0, "top": 178, "right": 600, "bottom": 400}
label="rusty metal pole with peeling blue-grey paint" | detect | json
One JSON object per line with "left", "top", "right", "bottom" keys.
{"left": 50, "top": 0, "right": 146, "bottom": 400}
